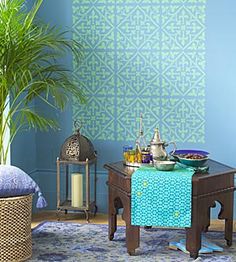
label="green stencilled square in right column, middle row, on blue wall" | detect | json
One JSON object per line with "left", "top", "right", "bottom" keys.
{"left": 161, "top": 51, "right": 205, "bottom": 98}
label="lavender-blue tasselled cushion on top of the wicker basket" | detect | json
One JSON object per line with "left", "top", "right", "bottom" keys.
{"left": 0, "top": 165, "right": 47, "bottom": 208}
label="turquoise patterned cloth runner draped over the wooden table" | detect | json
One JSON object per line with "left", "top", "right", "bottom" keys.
{"left": 131, "top": 166, "right": 194, "bottom": 227}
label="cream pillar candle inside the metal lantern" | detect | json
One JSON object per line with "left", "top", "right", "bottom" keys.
{"left": 71, "top": 173, "right": 83, "bottom": 207}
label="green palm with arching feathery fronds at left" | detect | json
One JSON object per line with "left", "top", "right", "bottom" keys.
{"left": 0, "top": 0, "right": 85, "bottom": 163}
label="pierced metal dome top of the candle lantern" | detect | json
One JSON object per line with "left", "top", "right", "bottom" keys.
{"left": 60, "top": 125, "right": 96, "bottom": 161}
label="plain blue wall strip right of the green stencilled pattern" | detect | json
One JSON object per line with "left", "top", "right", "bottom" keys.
{"left": 205, "top": 0, "right": 236, "bottom": 166}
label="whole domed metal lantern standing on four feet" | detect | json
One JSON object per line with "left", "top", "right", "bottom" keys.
{"left": 57, "top": 121, "right": 97, "bottom": 222}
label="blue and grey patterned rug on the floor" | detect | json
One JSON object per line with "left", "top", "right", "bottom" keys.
{"left": 29, "top": 222, "right": 236, "bottom": 262}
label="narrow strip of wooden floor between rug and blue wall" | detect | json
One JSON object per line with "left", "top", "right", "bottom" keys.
{"left": 31, "top": 211, "right": 236, "bottom": 232}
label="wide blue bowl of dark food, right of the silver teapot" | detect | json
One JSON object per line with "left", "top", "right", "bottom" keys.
{"left": 170, "top": 149, "right": 209, "bottom": 167}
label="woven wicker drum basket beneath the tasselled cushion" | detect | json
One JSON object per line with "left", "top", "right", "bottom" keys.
{"left": 0, "top": 194, "right": 33, "bottom": 261}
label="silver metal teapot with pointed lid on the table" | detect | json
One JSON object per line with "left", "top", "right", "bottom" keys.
{"left": 150, "top": 128, "right": 176, "bottom": 161}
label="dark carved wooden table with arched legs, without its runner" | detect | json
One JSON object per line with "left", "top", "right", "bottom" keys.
{"left": 104, "top": 160, "right": 236, "bottom": 259}
